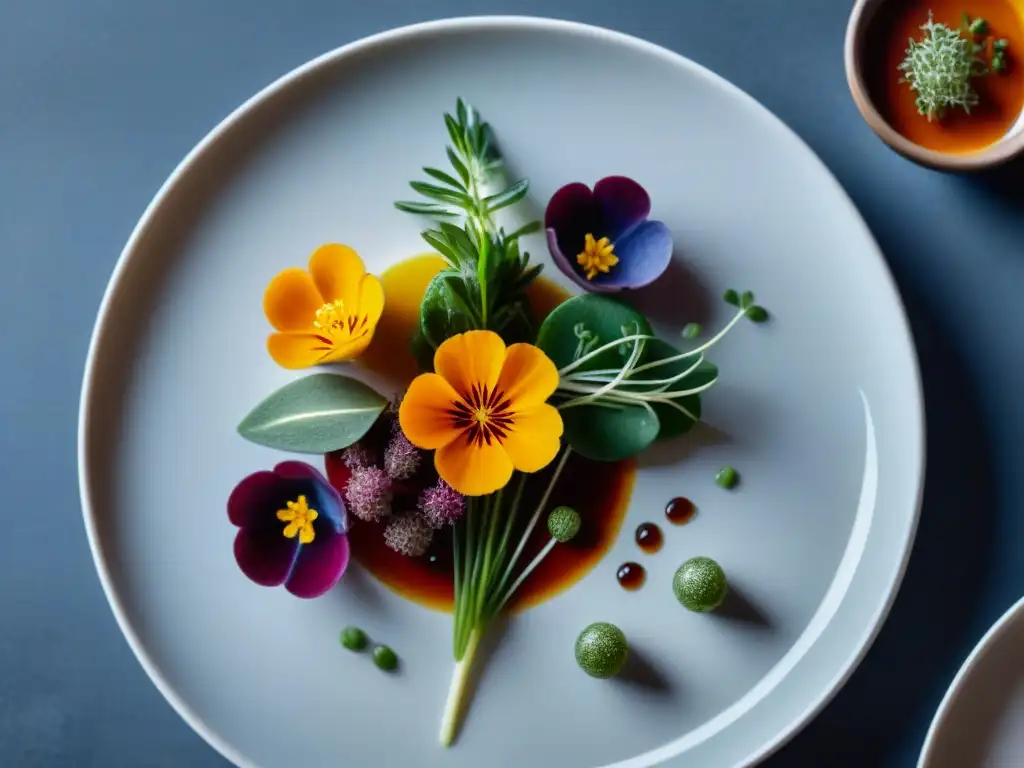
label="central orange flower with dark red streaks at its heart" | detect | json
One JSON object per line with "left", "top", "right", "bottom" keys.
{"left": 398, "top": 331, "right": 562, "bottom": 496}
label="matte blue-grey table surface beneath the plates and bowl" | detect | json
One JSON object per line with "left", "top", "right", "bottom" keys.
{"left": 0, "top": 0, "right": 1024, "bottom": 768}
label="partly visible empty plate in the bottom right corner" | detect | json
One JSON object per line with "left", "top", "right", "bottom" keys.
{"left": 918, "top": 598, "right": 1024, "bottom": 768}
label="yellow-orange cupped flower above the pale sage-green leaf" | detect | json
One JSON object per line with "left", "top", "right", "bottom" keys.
{"left": 263, "top": 243, "right": 384, "bottom": 369}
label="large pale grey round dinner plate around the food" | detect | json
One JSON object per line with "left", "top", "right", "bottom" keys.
{"left": 79, "top": 17, "right": 924, "bottom": 768}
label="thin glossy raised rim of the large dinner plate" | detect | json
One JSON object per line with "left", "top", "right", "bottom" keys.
{"left": 77, "top": 14, "right": 929, "bottom": 768}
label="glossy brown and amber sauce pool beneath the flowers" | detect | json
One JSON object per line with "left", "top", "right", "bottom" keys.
{"left": 325, "top": 255, "right": 636, "bottom": 611}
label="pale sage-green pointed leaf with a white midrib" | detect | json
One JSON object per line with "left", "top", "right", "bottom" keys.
{"left": 239, "top": 374, "right": 387, "bottom": 454}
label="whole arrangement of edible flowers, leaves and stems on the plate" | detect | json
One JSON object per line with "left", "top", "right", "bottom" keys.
{"left": 227, "top": 99, "right": 767, "bottom": 745}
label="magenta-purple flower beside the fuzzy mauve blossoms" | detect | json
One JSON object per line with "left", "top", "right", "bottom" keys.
{"left": 227, "top": 462, "right": 348, "bottom": 598}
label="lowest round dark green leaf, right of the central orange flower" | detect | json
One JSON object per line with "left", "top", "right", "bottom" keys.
{"left": 560, "top": 406, "right": 660, "bottom": 462}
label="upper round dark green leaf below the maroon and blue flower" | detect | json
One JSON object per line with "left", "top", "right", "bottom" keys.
{"left": 537, "top": 293, "right": 653, "bottom": 371}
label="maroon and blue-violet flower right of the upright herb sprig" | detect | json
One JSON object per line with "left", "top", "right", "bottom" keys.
{"left": 544, "top": 176, "right": 672, "bottom": 293}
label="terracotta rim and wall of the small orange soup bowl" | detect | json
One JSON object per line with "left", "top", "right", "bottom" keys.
{"left": 844, "top": 0, "right": 1024, "bottom": 173}
